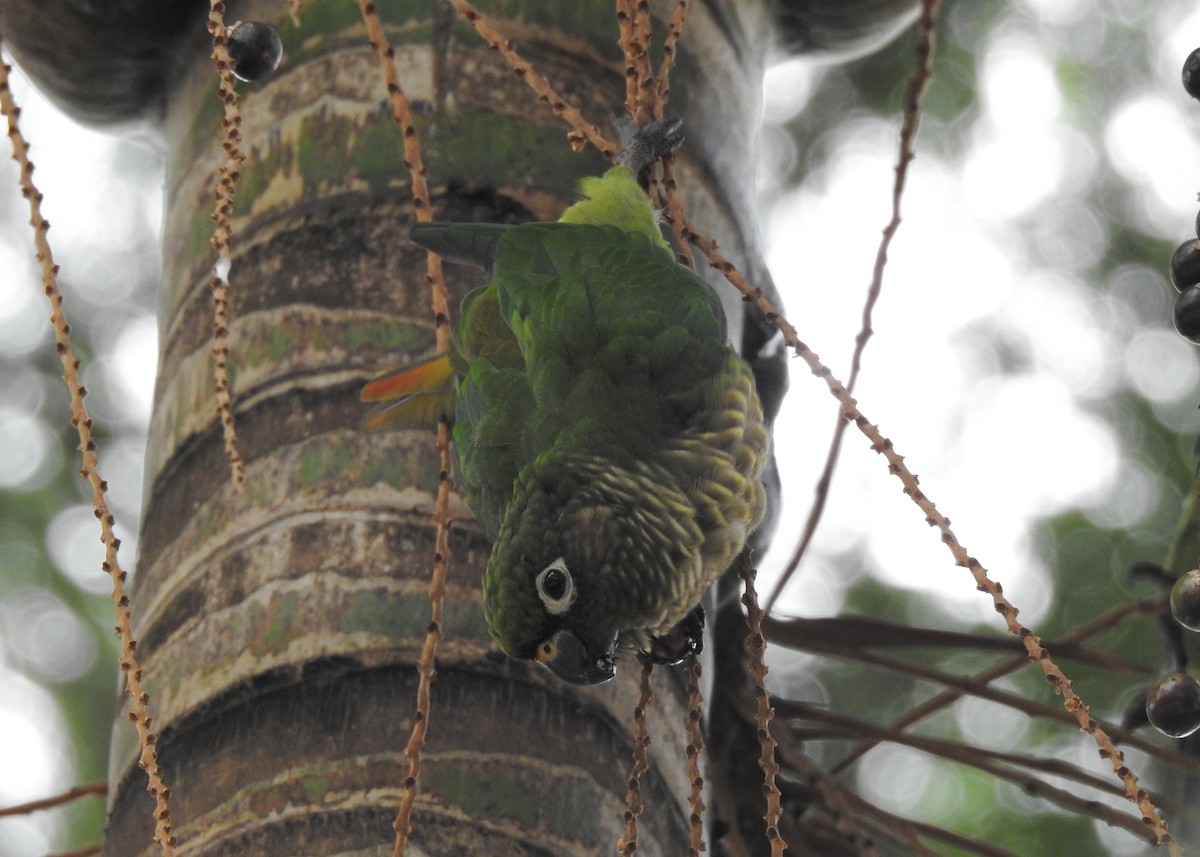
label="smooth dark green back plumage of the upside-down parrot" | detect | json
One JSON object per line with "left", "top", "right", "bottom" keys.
{"left": 494, "top": 223, "right": 728, "bottom": 453}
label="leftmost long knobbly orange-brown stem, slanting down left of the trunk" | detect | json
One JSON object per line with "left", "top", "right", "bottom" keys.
{"left": 0, "top": 50, "right": 175, "bottom": 857}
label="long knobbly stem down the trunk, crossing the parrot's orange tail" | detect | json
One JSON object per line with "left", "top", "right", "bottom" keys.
{"left": 359, "top": 0, "right": 452, "bottom": 857}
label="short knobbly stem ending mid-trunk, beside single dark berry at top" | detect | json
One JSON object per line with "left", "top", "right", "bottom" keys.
{"left": 209, "top": 0, "right": 246, "bottom": 492}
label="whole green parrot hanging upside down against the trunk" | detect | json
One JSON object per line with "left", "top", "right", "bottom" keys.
{"left": 362, "top": 133, "right": 769, "bottom": 684}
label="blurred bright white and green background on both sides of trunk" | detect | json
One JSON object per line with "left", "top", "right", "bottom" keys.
{"left": 0, "top": 0, "right": 1200, "bottom": 857}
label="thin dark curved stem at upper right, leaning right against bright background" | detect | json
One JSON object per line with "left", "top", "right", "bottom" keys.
{"left": 766, "top": 0, "right": 940, "bottom": 616}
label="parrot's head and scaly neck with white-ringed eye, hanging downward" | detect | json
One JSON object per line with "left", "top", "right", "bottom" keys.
{"left": 484, "top": 458, "right": 703, "bottom": 684}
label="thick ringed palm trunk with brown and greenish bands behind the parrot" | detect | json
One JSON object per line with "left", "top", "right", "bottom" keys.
{"left": 104, "top": 0, "right": 779, "bottom": 857}
